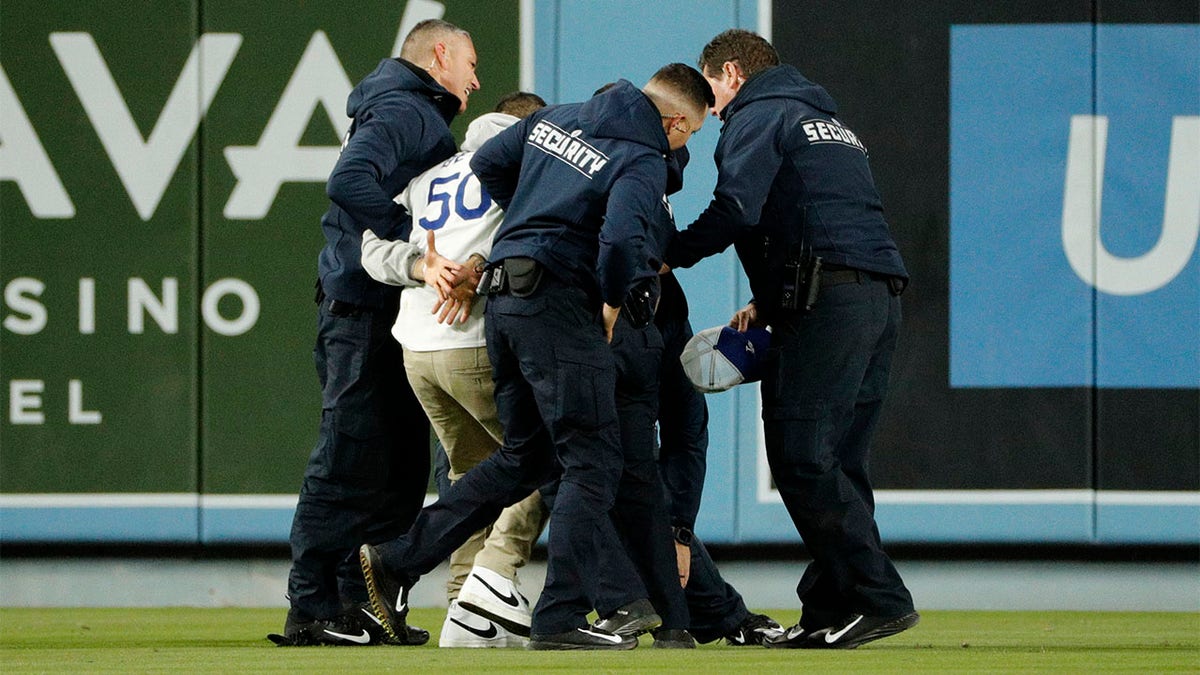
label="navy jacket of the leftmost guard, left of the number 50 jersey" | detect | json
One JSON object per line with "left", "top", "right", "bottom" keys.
{"left": 318, "top": 59, "right": 460, "bottom": 307}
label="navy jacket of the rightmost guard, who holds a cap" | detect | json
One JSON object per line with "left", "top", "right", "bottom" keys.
{"left": 666, "top": 65, "right": 907, "bottom": 313}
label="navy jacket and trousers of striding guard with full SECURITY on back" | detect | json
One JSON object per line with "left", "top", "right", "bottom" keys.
{"left": 376, "top": 80, "right": 666, "bottom": 637}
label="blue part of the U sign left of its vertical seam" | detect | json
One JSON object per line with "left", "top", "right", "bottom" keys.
{"left": 950, "top": 24, "right": 1094, "bottom": 387}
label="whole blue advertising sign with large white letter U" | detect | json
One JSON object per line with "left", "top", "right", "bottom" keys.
{"left": 950, "top": 24, "right": 1200, "bottom": 388}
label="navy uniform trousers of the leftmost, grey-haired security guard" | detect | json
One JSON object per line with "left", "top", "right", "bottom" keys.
{"left": 288, "top": 299, "right": 430, "bottom": 620}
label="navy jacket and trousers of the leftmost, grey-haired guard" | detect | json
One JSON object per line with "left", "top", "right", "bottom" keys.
{"left": 288, "top": 59, "right": 460, "bottom": 620}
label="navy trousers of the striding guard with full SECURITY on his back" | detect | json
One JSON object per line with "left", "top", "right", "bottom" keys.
{"left": 379, "top": 274, "right": 647, "bottom": 634}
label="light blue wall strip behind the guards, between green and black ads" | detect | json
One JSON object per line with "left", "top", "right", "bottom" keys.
{"left": 534, "top": 0, "right": 757, "bottom": 542}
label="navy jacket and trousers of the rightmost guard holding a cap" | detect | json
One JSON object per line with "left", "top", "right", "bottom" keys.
{"left": 666, "top": 65, "right": 913, "bottom": 629}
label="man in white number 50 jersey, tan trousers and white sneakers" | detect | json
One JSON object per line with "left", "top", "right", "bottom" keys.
{"left": 362, "top": 94, "right": 546, "bottom": 647}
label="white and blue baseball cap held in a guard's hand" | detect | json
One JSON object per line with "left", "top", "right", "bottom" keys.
{"left": 679, "top": 325, "right": 770, "bottom": 394}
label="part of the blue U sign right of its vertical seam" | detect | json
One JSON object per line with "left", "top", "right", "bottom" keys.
{"left": 1094, "top": 25, "right": 1200, "bottom": 388}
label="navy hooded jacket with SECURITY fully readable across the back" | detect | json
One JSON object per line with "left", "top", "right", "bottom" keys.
{"left": 470, "top": 79, "right": 668, "bottom": 306}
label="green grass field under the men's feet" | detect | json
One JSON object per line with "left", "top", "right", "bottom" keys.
{"left": 0, "top": 608, "right": 1200, "bottom": 675}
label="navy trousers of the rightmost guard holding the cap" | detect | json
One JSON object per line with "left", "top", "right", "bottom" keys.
{"left": 762, "top": 274, "right": 913, "bottom": 629}
